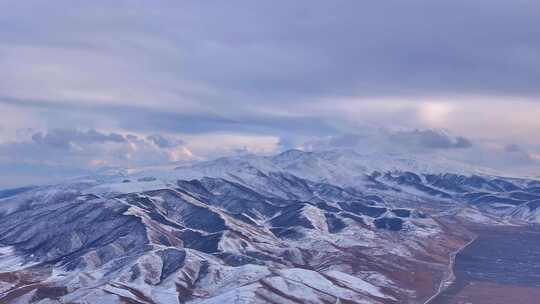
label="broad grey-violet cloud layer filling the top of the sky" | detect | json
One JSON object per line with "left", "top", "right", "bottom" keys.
{"left": 0, "top": 0, "right": 540, "bottom": 111}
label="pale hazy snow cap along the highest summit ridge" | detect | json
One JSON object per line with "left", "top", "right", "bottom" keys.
{"left": 123, "top": 150, "right": 495, "bottom": 194}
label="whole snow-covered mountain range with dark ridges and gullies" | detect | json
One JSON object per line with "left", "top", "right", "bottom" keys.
{"left": 0, "top": 150, "right": 540, "bottom": 304}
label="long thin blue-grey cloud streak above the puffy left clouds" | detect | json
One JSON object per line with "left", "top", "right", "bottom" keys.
{"left": 0, "top": 96, "right": 338, "bottom": 138}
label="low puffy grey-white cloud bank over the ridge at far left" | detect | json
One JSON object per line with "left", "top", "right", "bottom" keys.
{"left": 0, "top": 129, "right": 187, "bottom": 171}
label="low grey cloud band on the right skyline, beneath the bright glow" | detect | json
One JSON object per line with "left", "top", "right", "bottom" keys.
{"left": 298, "top": 129, "right": 540, "bottom": 176}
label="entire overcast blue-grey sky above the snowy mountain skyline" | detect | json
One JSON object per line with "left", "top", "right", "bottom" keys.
{"left": 0, "top": 0, "right": 540, "bottom": 188}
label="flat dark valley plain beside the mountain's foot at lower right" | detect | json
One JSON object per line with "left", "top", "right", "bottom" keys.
{"left": 428, "top": 226, "right": 540, "bottom": 304}
